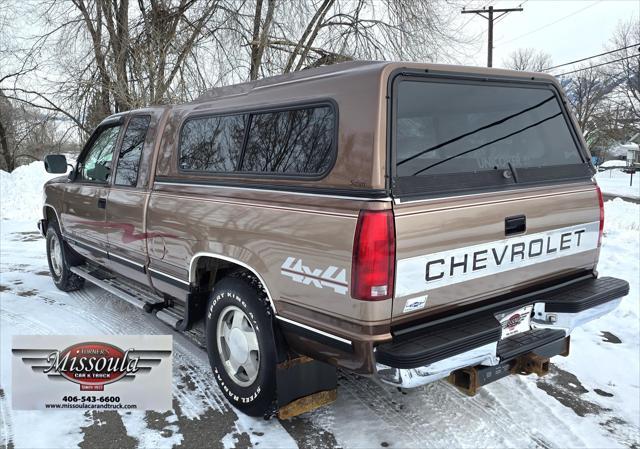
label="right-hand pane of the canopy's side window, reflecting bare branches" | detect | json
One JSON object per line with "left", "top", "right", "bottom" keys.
{"left": 241, "top": 106, "right": 335, "bottom": 174}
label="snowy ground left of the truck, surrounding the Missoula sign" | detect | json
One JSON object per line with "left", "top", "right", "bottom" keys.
{"left": 0, "top": 220, "right": 296, "bottom": 448}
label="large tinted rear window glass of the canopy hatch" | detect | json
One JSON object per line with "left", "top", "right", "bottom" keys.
{"left": 395, "top": 80, "right": 582, "bottom": 177}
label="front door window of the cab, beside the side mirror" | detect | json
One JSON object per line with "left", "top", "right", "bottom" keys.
{"left": 77, "top": 126, "right": 120, "bottom": 182}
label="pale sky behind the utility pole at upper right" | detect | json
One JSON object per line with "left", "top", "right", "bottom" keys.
{"left": 461, "top": 0, "right": 640, "bottom": 67}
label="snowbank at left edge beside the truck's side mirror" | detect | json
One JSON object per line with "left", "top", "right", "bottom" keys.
{"left": 0, "top": 161, "right": 60, "bottom": 220}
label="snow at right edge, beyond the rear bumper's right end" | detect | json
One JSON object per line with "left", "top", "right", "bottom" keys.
{"left": 554, "top": 198, "right": 640, "bottom": 422}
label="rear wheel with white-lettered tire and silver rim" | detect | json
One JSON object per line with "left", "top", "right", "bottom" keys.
{"left": 205, "top": 274, "right": 277, "bottom": 418}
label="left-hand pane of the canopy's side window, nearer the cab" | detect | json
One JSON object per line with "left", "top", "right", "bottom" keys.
{"left": 179, "top": 115, "right": 247, "bottom": 172}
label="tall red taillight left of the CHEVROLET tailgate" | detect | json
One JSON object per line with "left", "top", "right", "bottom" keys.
{"left": 351, "top": 210, "right": 396, "bottom": 301}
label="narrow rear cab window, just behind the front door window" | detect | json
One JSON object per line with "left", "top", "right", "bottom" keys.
{"left": 115, "top": 116, "right": 151, "bottom": 186}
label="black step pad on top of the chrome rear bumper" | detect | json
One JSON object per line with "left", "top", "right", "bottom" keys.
{"left": 376, "top": 277, "right": 629, "bottom": 369}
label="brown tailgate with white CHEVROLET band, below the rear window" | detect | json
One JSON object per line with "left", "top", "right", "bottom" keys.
{"left": 393, "top": 184, "right": 600, "bottom": 324}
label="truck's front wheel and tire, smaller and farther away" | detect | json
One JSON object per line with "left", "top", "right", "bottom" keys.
{"left": 46, "top": 221, "right": 84, "bottom": 292}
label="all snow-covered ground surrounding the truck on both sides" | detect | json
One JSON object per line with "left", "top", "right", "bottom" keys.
{"left": 0, "top": 159, "right": 640, "bottom": 448}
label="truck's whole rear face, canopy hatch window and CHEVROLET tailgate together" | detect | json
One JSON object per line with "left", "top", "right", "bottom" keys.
{"left": 390, "top": 73, "right": 600, "bottom": 324}
